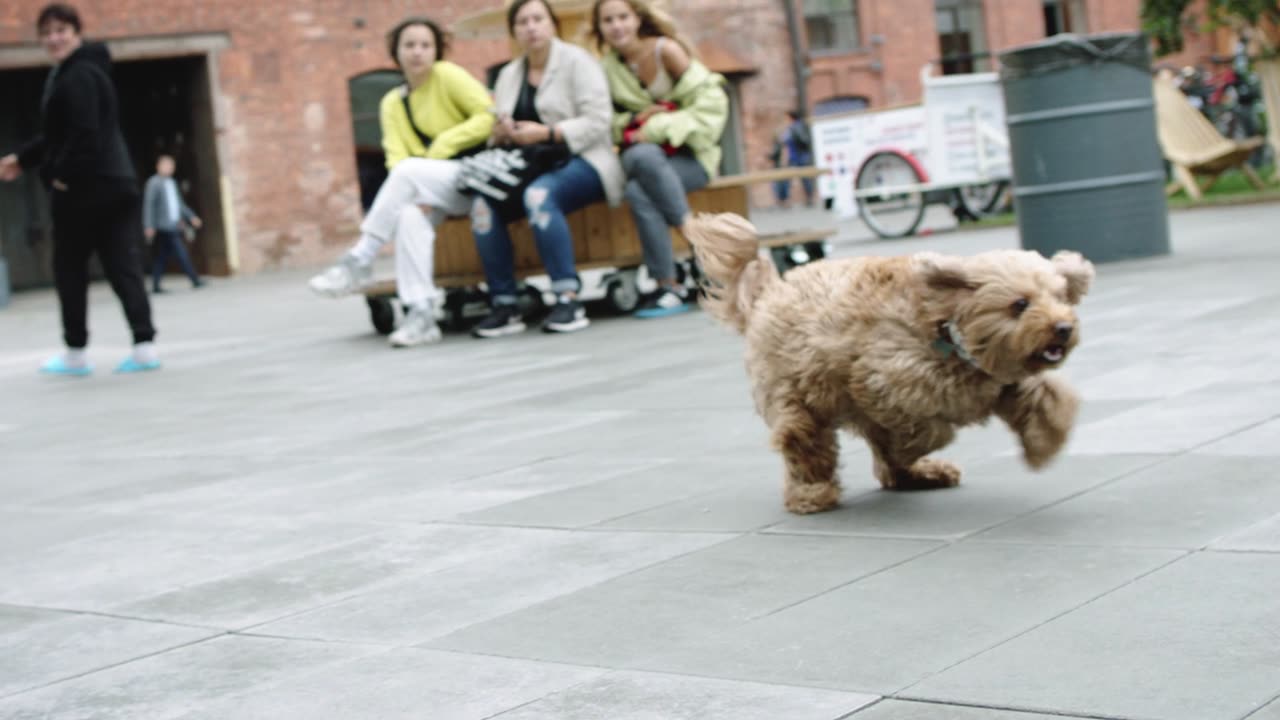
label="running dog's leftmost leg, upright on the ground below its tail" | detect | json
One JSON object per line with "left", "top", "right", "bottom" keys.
{"left": 771, "top": 405, "right": 840, "bottom": 515}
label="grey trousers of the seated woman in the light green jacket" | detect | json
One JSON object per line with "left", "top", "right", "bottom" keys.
{"left": 622, "top": 142, "right": 709, "bottom": 282}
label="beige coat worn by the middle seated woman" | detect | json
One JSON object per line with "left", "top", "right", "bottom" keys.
{"left": 493, "top": 38, "right": 626, "bottom": 205}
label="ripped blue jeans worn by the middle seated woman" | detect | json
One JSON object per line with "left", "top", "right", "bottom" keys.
{"left": 471, "top": 158, "right": 604, "bottom": 305}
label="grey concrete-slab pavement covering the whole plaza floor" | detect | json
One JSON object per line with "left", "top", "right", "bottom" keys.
{"left": 0, "top": 206, "right": 1280, "bottom": 720}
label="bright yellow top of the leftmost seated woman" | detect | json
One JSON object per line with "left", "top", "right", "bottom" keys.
{"left": 379, "top": 60, "right": 494, "bottom": 169}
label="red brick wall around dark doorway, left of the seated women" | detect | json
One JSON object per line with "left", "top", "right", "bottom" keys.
{"left": 0, "top": 0, "right": 506, "bottom": 273}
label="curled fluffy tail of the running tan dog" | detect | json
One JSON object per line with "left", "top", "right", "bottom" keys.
{"left": 686, "top": 213, "right": 778, "bottom": 332}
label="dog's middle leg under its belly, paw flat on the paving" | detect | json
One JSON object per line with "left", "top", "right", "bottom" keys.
{"left": 859, "top": 423, "right": 960, "bottom": 489}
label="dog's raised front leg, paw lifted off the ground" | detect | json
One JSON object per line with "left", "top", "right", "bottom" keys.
{"left": 996, "top": 375, "right": 1080, "bottom": 469}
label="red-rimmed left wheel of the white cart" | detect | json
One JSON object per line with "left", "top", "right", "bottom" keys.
{"left": 854, "top": 150, "right": 924, "bottom": 237}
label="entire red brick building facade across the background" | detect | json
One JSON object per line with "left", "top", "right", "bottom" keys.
{"left": 0, "top": 0, "right": 1233, "bottom": 273}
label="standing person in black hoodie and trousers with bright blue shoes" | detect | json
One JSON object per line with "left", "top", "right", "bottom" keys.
{"left": 0, "top": 3, "right": 160, "bottom": 375}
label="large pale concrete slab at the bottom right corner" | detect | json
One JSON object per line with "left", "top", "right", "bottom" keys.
{"left": 902, "top": 552, "right": 1280, "bottom": 720}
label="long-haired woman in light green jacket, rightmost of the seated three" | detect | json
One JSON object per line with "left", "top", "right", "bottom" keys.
{"left": 591, "top": 0, "right": 728, "bottom": 318}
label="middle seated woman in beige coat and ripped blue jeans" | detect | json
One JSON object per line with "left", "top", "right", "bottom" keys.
{"left": 471, "top": 0, "right": 625, "bottom": 337}
